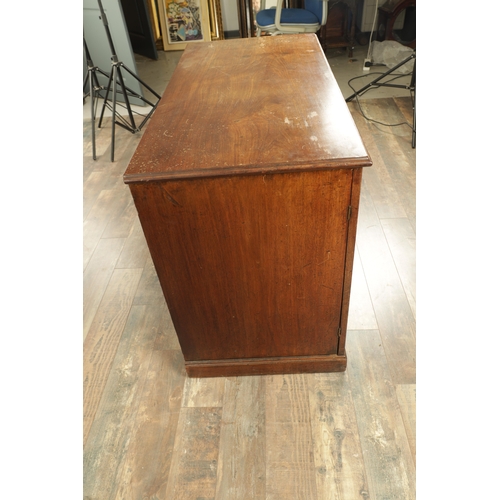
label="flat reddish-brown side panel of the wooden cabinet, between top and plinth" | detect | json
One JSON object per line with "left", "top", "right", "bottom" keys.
{"left": 130, "top": 169, "right": 353, "bottom": 361}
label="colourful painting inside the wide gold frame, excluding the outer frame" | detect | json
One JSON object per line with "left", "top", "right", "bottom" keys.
{"left": 164, "top": 0, "right": 204, "bottom": 43}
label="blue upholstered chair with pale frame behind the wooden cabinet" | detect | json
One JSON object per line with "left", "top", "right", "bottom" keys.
{"left": 256, "top": 0, "right": 328, "bottom": 36}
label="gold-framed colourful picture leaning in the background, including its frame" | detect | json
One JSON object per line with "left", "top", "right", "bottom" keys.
{"left": 160, "top": 0, "right": 212, "bottom": 50}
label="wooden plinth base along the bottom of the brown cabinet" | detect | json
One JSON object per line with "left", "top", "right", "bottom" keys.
{"left": 186, "top": 354, "right": 347, "bottom": 378}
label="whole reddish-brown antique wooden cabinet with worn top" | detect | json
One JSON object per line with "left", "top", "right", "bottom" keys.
{"left": 124, "top": 34, "right": 371, "bottom": 377}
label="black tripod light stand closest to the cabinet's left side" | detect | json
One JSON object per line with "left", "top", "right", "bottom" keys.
{"left": 94, "top": 0, "right": 161, "bottom": 161}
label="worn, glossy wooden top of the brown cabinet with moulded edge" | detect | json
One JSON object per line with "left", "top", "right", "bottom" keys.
{"left": 124, "top": 34, "right": 371, "bottom": 183}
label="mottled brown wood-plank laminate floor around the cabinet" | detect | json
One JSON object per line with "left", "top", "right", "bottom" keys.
{"left": 83, "top": 97, "right": 418, "bottom": 500}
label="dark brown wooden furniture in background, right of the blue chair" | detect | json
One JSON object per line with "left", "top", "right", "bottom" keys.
{"left": 318, "top": 0, "right": 357, "bottom": 57}
